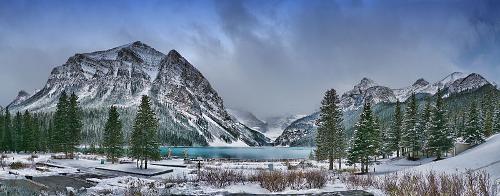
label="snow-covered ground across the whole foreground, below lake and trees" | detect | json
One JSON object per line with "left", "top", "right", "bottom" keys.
{"left": 0, "top": 135, "right": 500, "bottom": 195}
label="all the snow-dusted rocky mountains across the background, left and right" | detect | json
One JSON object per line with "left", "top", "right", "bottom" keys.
{"left": 0, "top": 41, "right": 496, "bottom": 146}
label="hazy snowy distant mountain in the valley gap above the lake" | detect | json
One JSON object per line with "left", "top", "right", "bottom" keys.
{"left": 227, "top": 109, "right": 305, "bottom": 140}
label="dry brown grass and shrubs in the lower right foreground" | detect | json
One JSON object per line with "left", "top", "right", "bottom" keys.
{"left": 340, "top": 171, "right": 492, "bottom": 196}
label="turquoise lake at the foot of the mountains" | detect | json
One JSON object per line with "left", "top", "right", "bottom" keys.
{"left": 161, "top": 147, "right": 313, "bottom": 160}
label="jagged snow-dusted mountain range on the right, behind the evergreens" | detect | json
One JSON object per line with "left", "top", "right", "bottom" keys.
{"left": 274, "top": 72, "right": 496, "bottom": 146}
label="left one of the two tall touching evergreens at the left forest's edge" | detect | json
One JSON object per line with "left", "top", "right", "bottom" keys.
{"left": 50, "top": 91, "right": 69, "bottom": 155}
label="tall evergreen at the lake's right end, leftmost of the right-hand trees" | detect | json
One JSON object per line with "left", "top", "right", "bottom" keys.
{"left": 316, "top": 89, "right": 346, "bottom": 170}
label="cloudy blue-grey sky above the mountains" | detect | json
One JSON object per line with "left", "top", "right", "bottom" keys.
{"left": 0, "top": 0, "right": 500, "bottom": 117}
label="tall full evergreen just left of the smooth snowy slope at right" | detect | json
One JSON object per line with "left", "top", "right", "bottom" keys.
{"left": 427, "top": 89, "right": 453, "bottom": 160}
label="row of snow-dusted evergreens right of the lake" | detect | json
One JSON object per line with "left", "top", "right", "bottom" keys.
{"left": 315, "top": 89, "right": 500, "bottom": 173}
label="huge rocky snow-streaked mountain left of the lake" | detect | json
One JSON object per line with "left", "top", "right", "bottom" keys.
{"left": 9, "top": 41, "right": 269, "bottom": 146}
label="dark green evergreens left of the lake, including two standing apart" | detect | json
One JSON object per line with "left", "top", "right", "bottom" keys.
{"left": 0, "top": 91, "right": 160, "bottom": 169}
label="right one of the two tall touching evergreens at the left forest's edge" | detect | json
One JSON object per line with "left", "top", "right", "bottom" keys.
{"left": 65, "top": 93, "right": 83, "bottom": 155}
